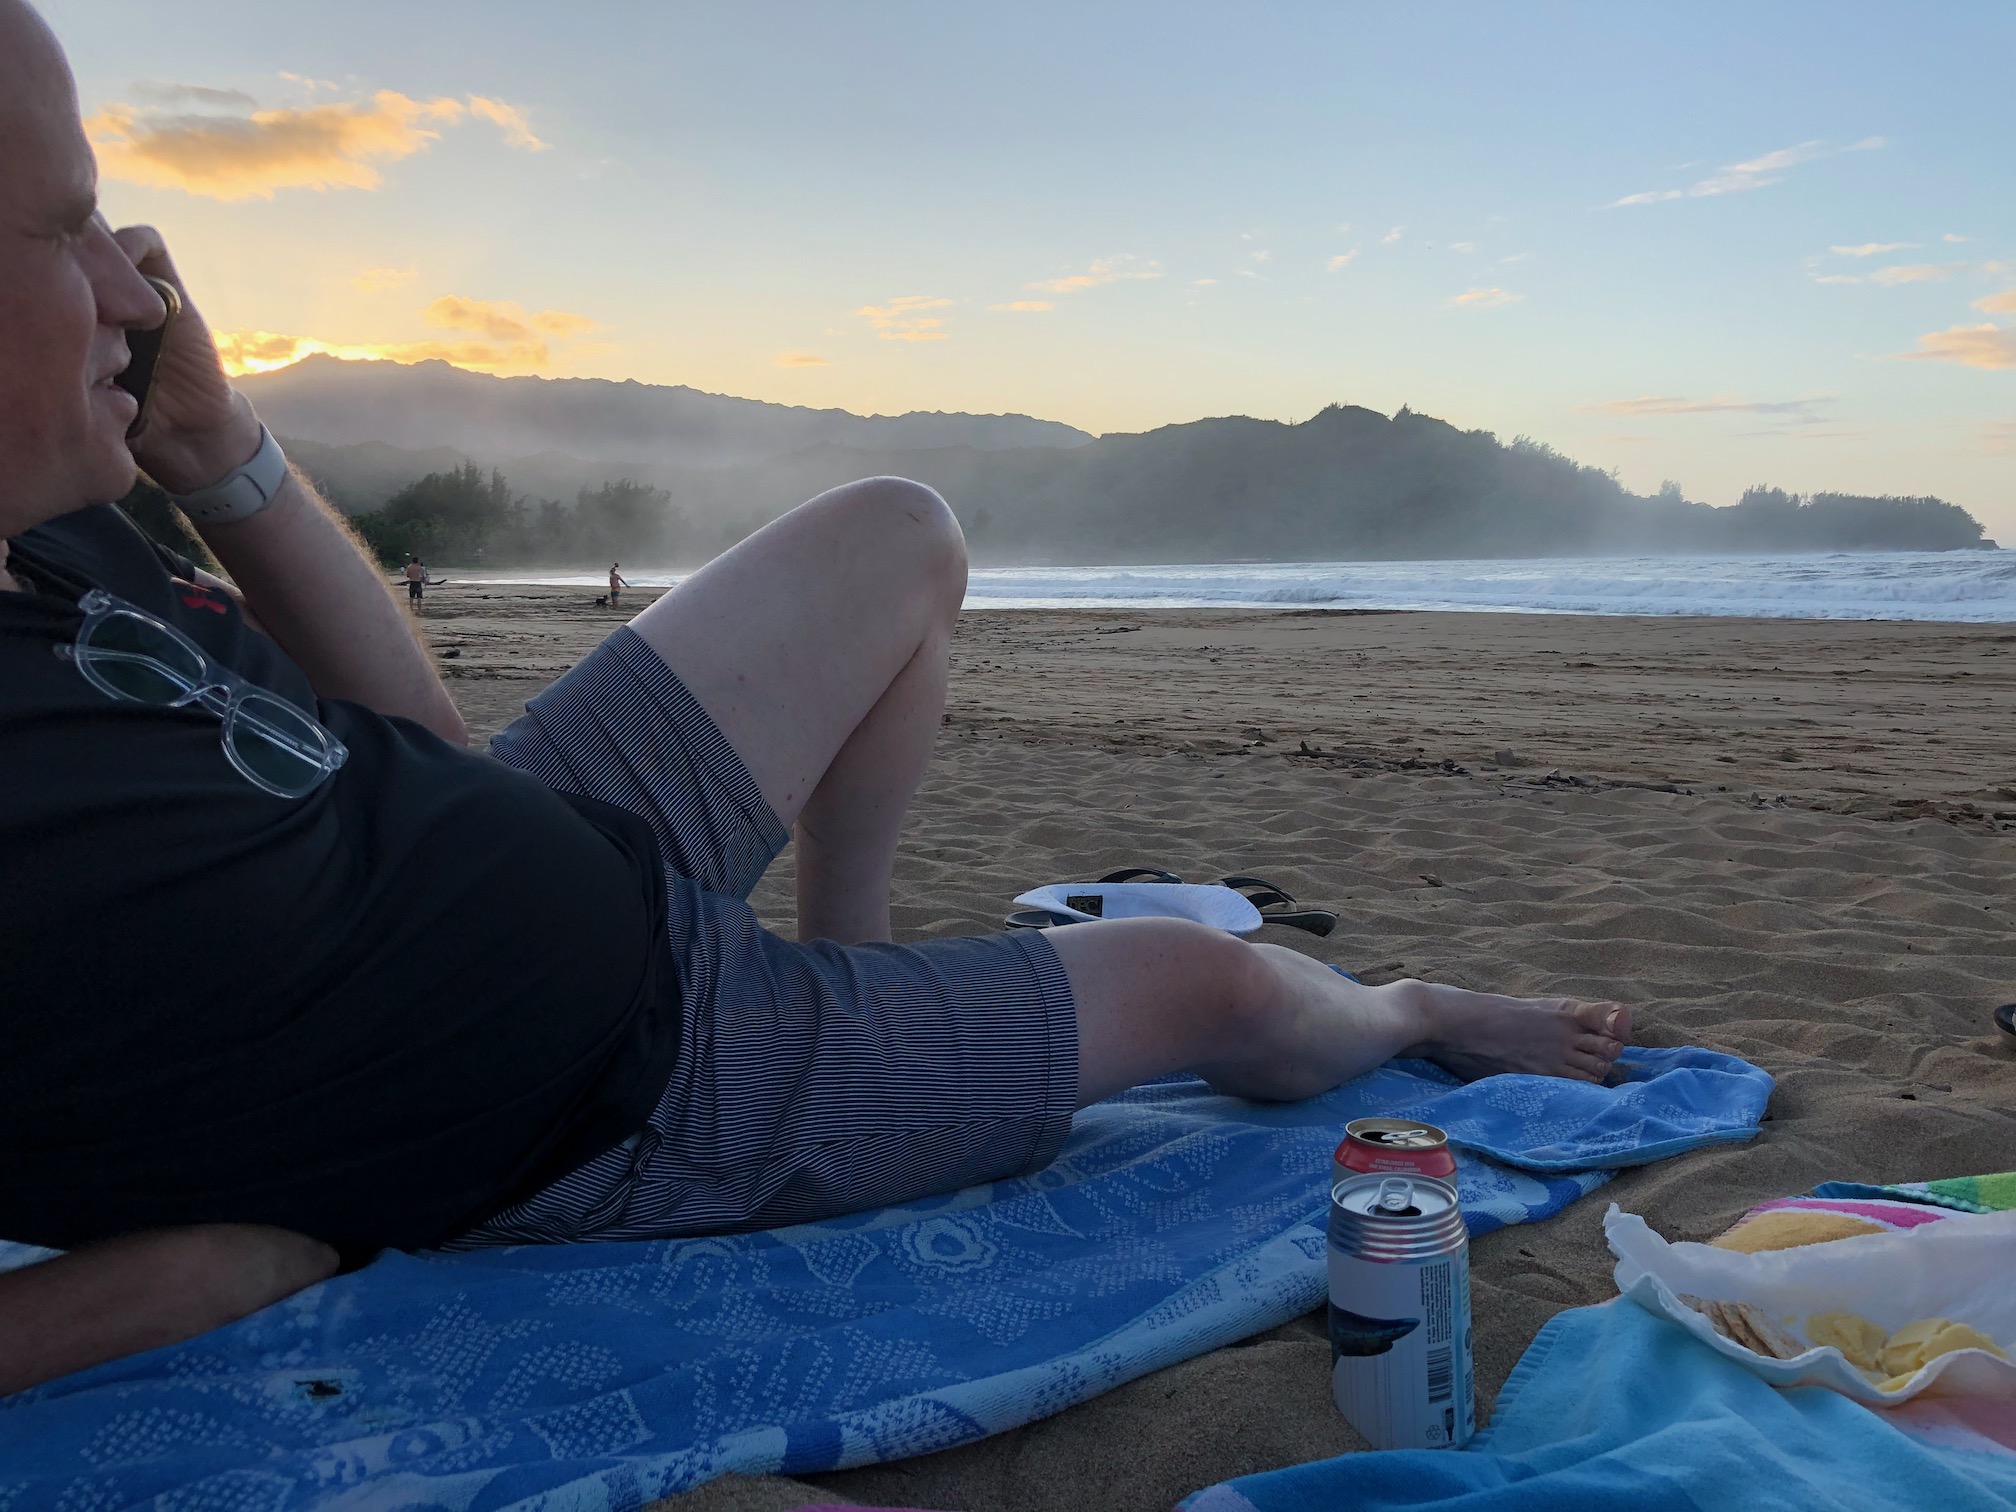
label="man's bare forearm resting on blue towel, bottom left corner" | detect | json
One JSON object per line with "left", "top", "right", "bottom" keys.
{"left": 0, "top": 1224, "right": 339, "bottom": 1397}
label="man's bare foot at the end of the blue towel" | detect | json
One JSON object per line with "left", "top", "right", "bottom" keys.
{"left": 1405, "top": 982, "right": 1631, "bottom": 1081}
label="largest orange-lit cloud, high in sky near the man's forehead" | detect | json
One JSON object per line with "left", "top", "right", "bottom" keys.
{"left": 85, "top": 85, "right": 544, "bottom": 200}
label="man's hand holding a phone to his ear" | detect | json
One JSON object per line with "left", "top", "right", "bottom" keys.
{"left": 113, "top": 226, "right": 258, "bottom": 494}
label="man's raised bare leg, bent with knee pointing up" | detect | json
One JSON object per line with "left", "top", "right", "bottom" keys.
{"left": 631, "top": 478, "right": 966, "bottom": 943}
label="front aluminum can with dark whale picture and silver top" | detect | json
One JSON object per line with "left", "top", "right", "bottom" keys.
{"left": 1331, "top": 1173, "right": 1476, "bottom": 1450}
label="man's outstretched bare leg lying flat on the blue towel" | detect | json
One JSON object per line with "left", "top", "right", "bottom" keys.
{"left": 1048, "top": 919, "right": 1631, "bottom": 1105}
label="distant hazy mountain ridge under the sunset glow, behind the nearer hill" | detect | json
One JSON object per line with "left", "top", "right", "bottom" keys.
{"left": 238, "top": 355, "right": 1093, "bottom": 468}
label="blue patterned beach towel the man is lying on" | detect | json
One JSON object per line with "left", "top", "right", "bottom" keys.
{"left": 0, "top": 1050, "right": 1770, "bottom": 1512}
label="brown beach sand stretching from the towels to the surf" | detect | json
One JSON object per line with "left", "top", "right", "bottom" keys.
{"left": 417, "top": 585, "right": 2016, "bottom": 1512}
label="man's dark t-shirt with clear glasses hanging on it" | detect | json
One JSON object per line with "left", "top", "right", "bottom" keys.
{"left": 0, "top": 506, "right": 679, "bottom": 1252}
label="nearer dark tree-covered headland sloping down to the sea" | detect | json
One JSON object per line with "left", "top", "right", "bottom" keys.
{"left": 651, "top": 405, "right": 1994, "bottom": 564}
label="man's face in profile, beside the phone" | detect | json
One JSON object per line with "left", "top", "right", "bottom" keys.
{"left": 0, "top": 0, "right": 161, "bottom": 538}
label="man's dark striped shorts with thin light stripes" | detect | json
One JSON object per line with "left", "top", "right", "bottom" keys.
{"left": 452, "top": 629, "right": 1079, "bottom": 1248}
